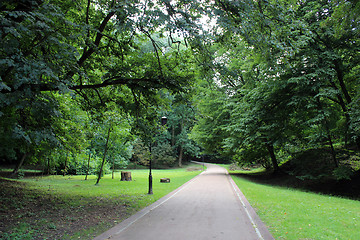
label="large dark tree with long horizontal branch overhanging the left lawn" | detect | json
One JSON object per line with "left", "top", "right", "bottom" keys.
{"left": 0, "top": 0, "right": 204, "bottom": 170}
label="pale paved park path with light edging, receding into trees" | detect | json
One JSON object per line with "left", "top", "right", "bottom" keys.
{"left": 95, "top": 164, "right": 273, "bottom": 240}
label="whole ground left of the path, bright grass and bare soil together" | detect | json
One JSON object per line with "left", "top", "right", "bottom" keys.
{"left": 0, "top": 166, "right": 201, "bottom": 239}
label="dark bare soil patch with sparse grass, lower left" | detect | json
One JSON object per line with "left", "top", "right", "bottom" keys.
{"left": 0, "top": 179, "right": 127, "bottom": 239}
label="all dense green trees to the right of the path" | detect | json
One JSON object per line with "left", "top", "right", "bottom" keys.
{"left": 191, "top": 0, "right": 360, "bottom": 178}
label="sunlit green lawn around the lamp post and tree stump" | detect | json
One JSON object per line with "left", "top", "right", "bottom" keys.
{"left": 21, "top": 168, "right": 200, "bottom": 211}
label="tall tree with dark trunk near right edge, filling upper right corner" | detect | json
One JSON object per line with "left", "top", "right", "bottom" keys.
{"left": 216, "top": 1, "right": 359, "bottom": 148}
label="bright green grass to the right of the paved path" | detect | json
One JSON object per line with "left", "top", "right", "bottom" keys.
{"left": 228, "top": 168, "right": 360, "bottom": 239}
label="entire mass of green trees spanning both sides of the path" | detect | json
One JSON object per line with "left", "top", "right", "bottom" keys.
{"left": 0, "top": 0, "right": 360, "bottom": 181}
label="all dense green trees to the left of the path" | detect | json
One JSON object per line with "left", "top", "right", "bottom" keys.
{"left": 0, "top": 0, "right": 204, "bottom": 176}
